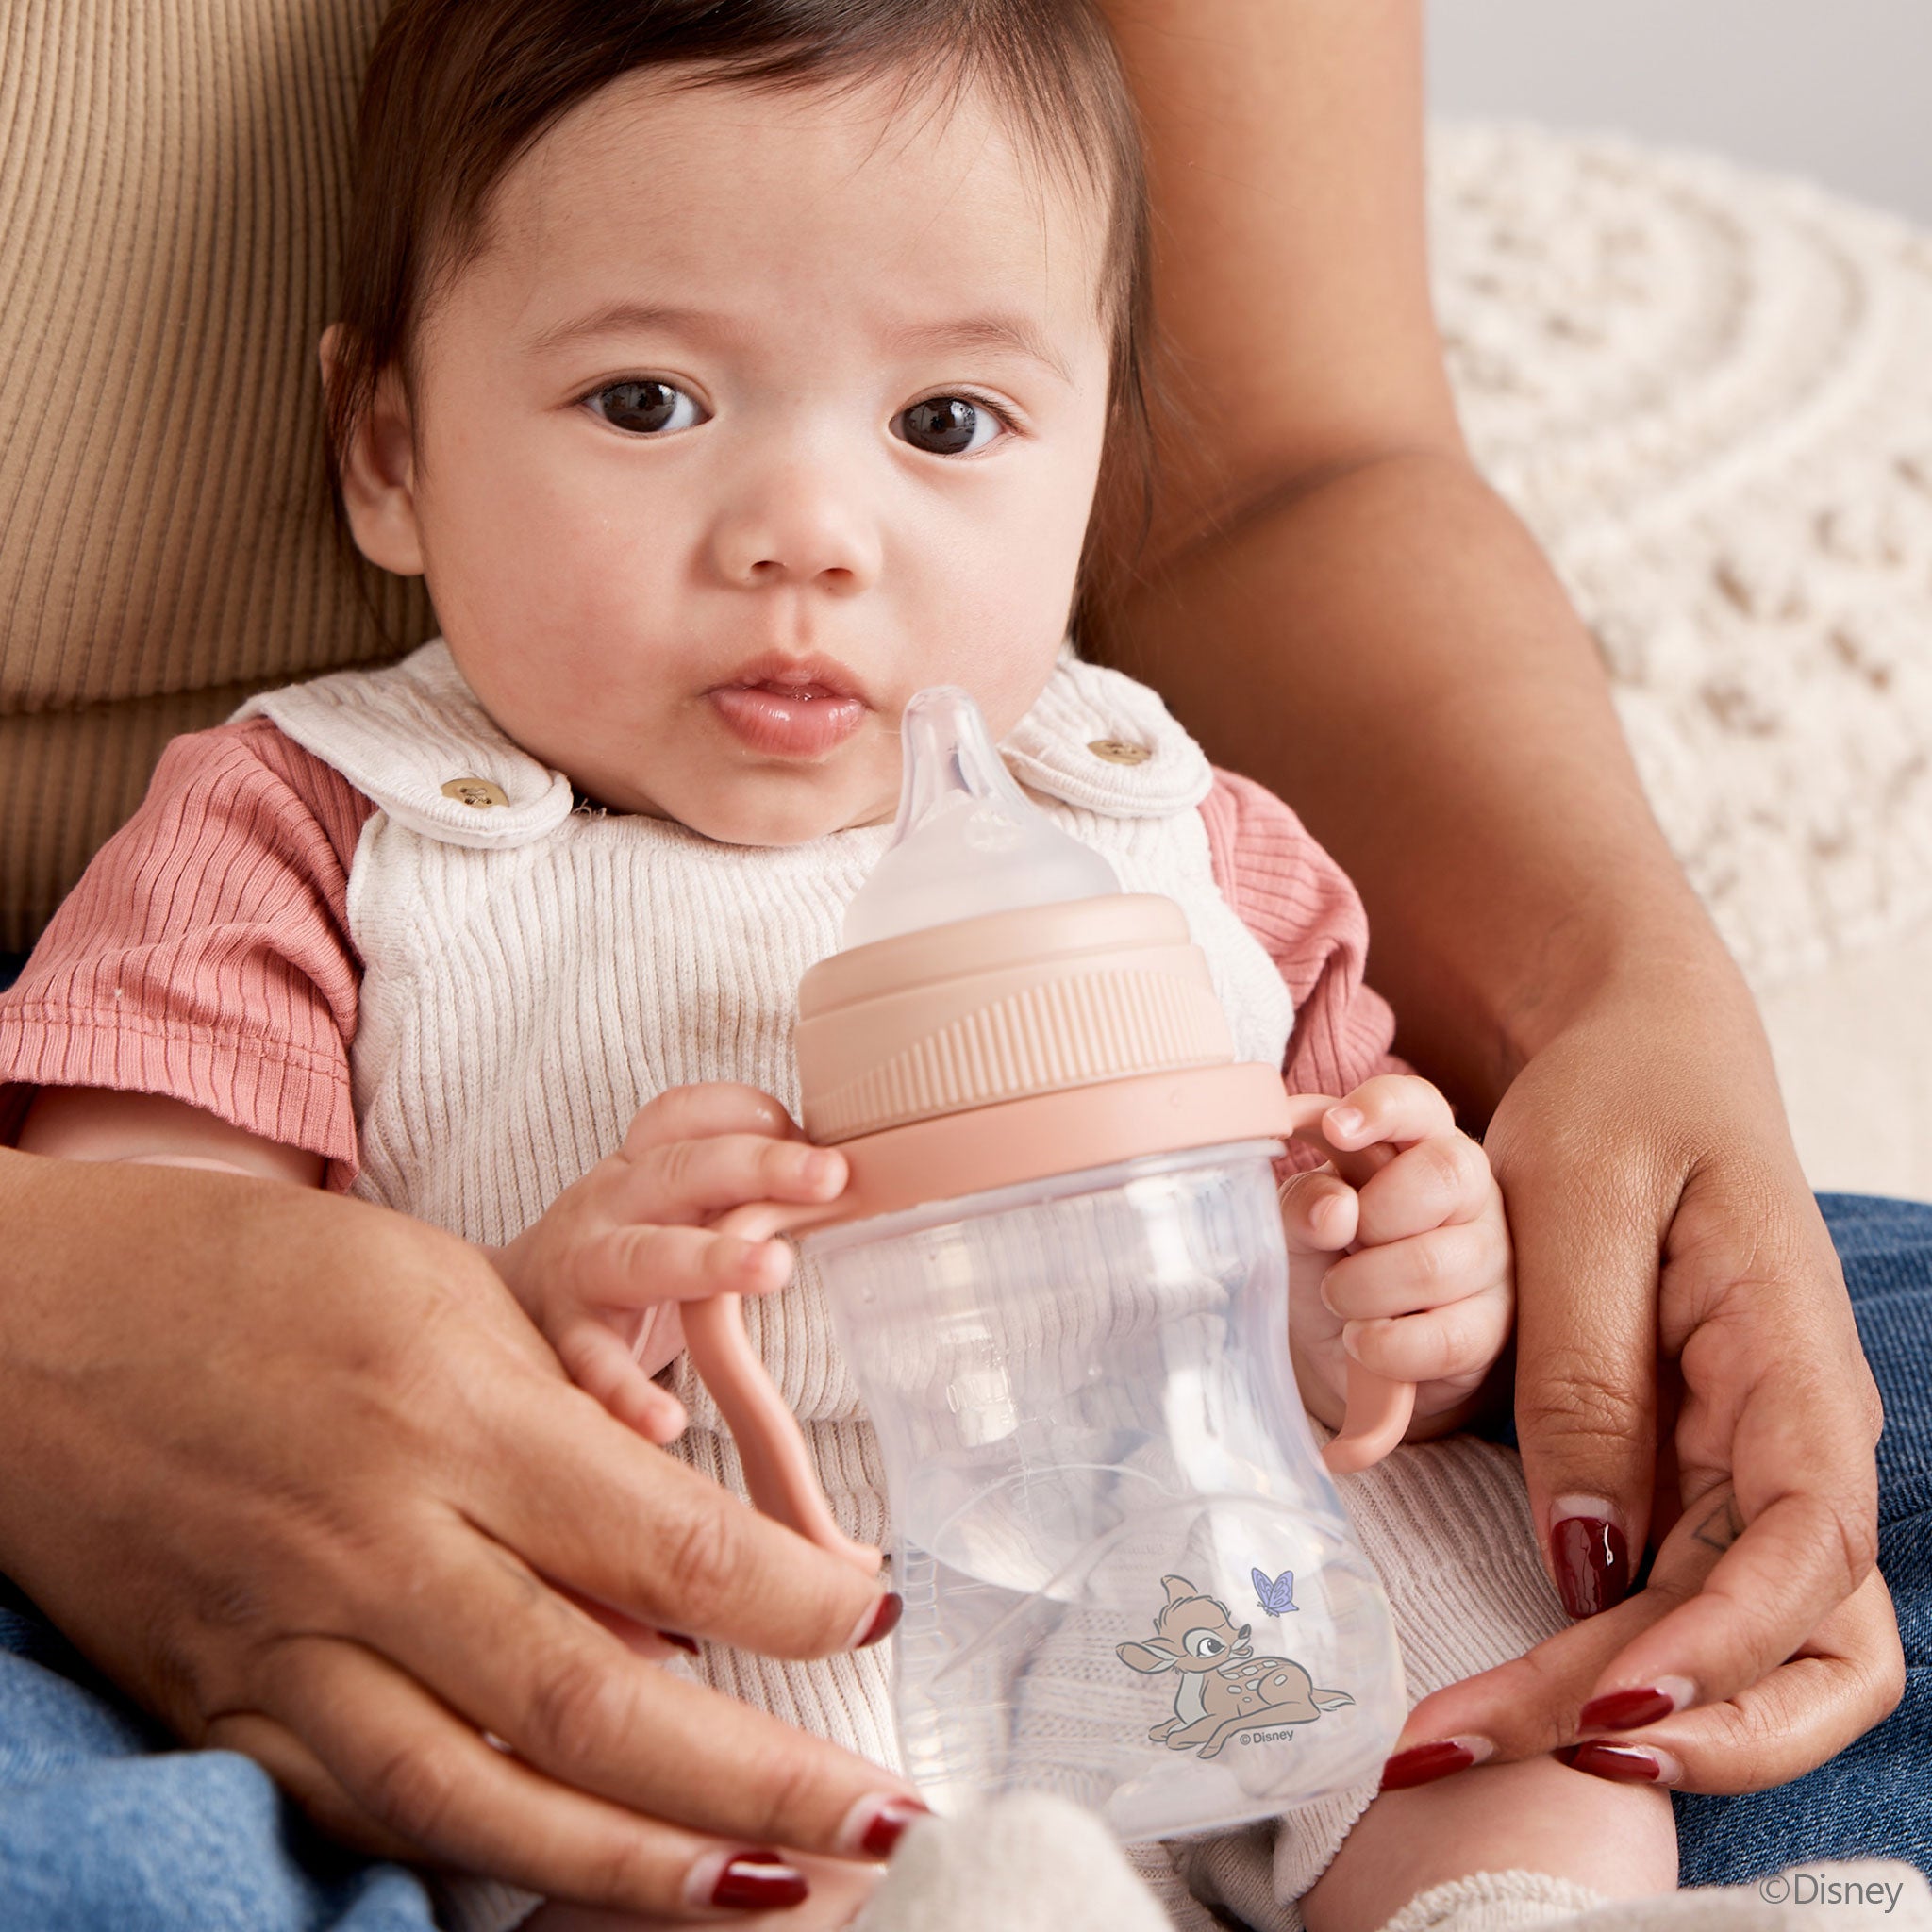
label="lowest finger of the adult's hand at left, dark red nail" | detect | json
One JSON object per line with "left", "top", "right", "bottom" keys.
{"left": 245, "top": 1637, "right": 826, "bottom": 1913}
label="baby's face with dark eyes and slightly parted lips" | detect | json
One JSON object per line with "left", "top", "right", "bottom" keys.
{"left": 378, "top": 75, "right": 1108, "bottom": 844}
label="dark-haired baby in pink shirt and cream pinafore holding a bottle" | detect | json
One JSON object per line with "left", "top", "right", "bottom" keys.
{"left": 0, "top": 0, "right": 1675, "bottom": 1932}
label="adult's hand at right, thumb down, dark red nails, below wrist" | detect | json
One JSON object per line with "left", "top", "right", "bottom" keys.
{"left": 1397, "top": 985, "right": 1903, "bottom": 1790}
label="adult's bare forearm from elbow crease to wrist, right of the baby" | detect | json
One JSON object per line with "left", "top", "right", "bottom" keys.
{"left": 1093, "top": 452, "right": 1762, "bottom": 1111}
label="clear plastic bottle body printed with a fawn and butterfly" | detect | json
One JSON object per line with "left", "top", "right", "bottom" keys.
{"left": 804, "top": 1141, "right": 1405, "bottom": 1840}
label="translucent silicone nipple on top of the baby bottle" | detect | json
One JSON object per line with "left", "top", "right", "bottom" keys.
{"left": 844, "top": 684, "right": 1121, "bottom": 947}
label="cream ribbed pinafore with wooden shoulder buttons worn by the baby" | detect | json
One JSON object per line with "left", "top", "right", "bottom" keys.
{"left": 243, "top": 643, "right": 1294, "bottom": 1764}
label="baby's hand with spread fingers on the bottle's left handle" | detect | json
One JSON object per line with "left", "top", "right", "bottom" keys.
{"left": 491, "top": 1080, "right": 846, "bottom": 1443}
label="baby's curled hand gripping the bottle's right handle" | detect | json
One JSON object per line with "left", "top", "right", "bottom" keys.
{"left": 1281, "top": 1074, "right": 1515, "bottom": 1436}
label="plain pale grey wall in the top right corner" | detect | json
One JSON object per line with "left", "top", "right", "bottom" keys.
{"left": 1427, "top": 0, "right": 1932, "bottom": 226}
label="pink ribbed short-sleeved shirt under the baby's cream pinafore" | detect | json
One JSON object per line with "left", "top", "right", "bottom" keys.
{"left": 0, "top": 719, "right": 1401, "bottom": 1191}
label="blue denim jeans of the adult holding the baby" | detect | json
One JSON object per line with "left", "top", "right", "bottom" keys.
{"left": 0, "top": 927, "right": 1932, "bottom": 1908}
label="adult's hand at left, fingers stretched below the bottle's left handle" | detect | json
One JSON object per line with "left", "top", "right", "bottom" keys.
{"left": 0, "top": 1152, "right": 916, "bottom": 1917}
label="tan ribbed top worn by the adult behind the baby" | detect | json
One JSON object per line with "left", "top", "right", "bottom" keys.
{"left": 0, "top": 0, "right": 429, "bottom": 951}
